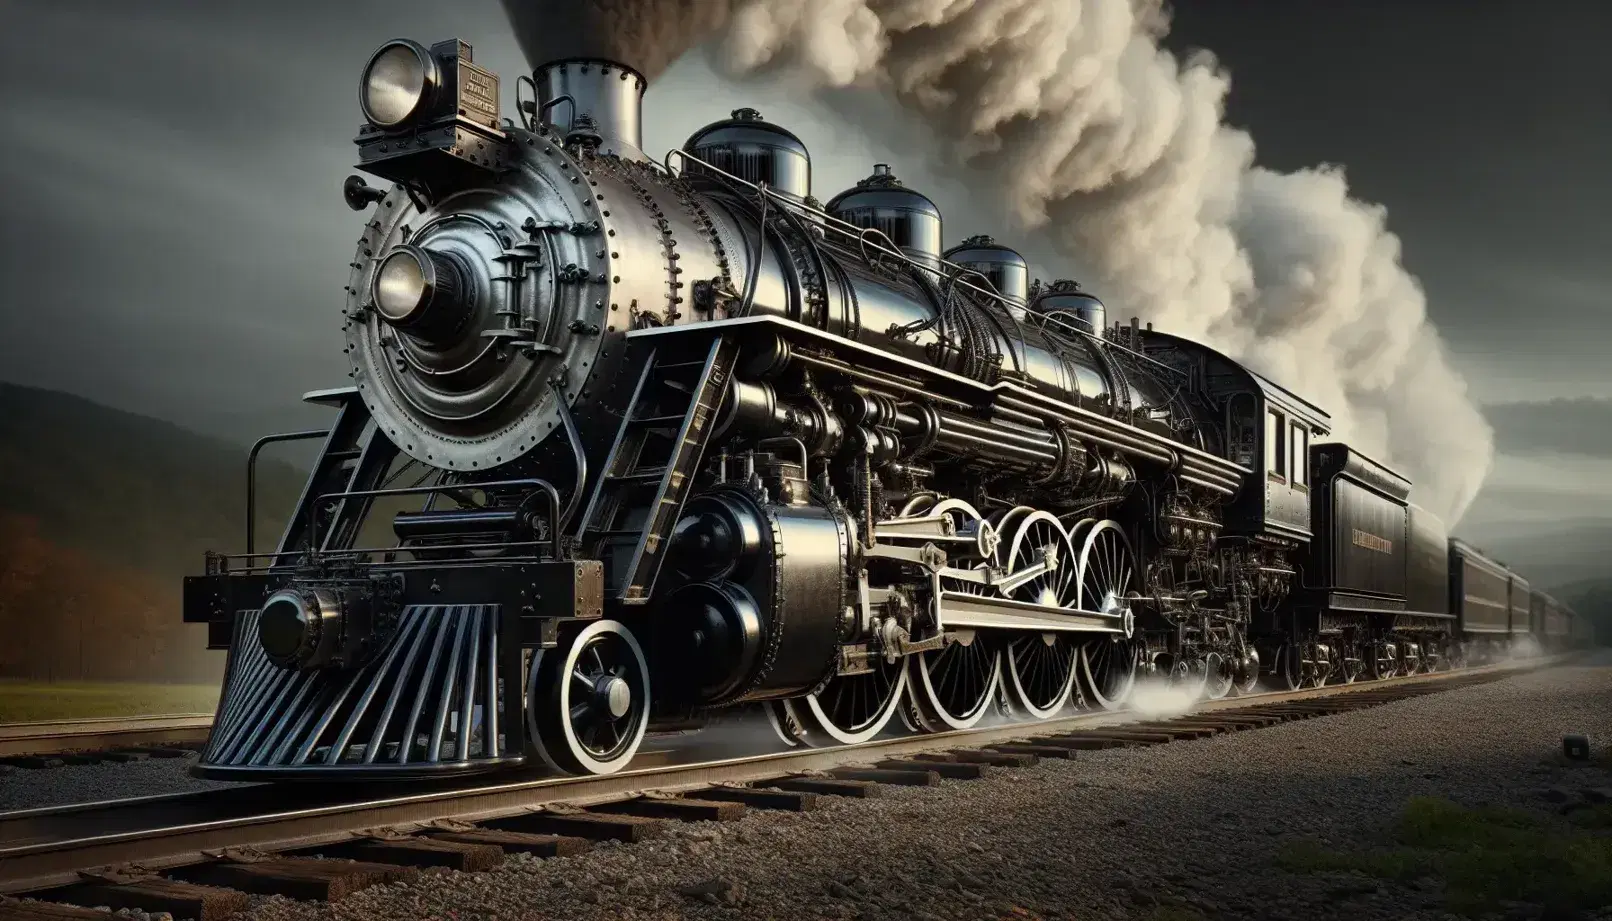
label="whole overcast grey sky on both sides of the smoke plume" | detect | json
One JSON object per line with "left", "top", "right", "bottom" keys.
{"left": 0, "top": 0, "right": 1612, "bottom": 541}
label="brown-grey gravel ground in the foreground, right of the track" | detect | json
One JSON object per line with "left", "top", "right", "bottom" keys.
{"left": 5, "top": 652, "right": 1612, "bottom": 921}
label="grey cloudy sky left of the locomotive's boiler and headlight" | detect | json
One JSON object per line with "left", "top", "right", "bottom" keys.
{"left": 0, "top": 0, "right": 521, "bottom": 437}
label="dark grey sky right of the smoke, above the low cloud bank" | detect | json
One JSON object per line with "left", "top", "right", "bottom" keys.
{"left": 1170, "top": 0, "right": 1612, "bottom": 402}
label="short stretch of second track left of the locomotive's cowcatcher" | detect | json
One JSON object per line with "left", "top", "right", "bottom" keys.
{"left": 0, "top": 713, "right": 213, "bottom": 768}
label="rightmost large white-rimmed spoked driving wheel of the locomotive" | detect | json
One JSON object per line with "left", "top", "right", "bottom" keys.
{"left": 1075, "top": 521, "right": 1140, "bottom": 710}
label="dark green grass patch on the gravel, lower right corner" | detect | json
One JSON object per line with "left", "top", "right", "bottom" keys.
{"left": 1277, "top": 797, "right": 1612, "bottom": 915}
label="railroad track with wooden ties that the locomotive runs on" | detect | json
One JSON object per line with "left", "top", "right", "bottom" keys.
{"left": 0, "top": 663, "right": 1548, "bottom": 921}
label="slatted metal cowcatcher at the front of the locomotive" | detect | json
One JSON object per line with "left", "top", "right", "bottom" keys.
{"left": 190, "top": 605, "right": 526, "bottom": 781}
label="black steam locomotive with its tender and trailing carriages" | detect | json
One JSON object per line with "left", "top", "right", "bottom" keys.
{"left": 184, "top": 16, "right": 1570, "bottom": 779}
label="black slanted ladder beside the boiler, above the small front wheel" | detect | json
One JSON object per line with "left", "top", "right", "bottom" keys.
{"left": 577, "top": 335, "right": 738, "bottom": 605}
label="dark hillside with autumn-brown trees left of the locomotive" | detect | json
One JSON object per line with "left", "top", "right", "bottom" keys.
{"left": 0, "top": 384, "right": 303, "bottom": 681}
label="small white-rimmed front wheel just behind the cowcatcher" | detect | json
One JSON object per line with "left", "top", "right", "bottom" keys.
{"left": 526, "top": 621, "right": 650, "bottom": 774}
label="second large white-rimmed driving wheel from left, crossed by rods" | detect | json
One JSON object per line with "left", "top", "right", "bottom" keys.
{"left": 908, "top": 498, "right": 1003, "bottom": 732}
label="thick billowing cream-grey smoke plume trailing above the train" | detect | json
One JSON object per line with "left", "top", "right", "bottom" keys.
{"left": 508, "top": 0, "right": 1493, "bottom": 524}
